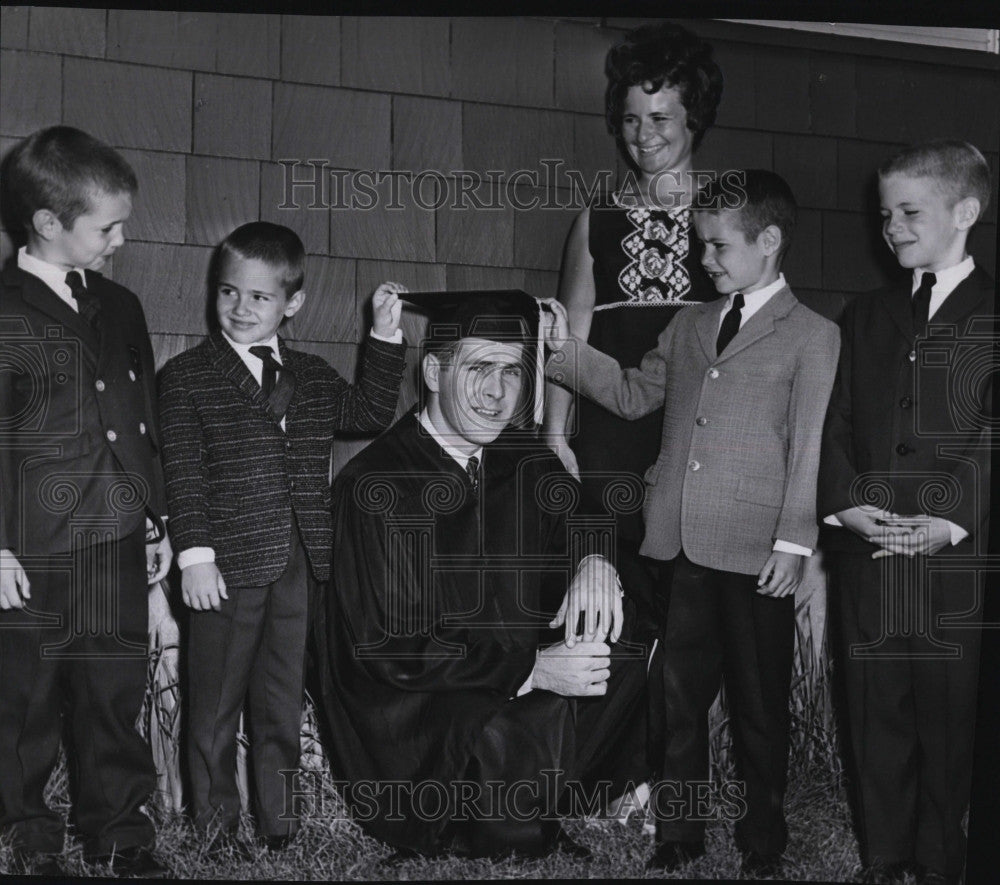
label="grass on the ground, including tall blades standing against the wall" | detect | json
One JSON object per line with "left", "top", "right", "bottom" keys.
{"left": 0, "top": 584, "right": 913, "bottom": 885}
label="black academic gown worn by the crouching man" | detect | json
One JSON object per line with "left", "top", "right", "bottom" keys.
{"left": 317, "top": 414, "right": 644, "bottom": 853}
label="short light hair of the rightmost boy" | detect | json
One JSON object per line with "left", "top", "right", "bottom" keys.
{"left": 878, "top": 141, "right": 990, "bottom": 218}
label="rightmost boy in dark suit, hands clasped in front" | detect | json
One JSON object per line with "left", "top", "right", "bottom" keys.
{"left": 819, "top": 142, "right": 995, "bottom": 882}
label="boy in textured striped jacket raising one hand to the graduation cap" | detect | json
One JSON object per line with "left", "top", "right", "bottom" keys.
{"left": 161, "top": 222, "right": 406, "bottom": 853}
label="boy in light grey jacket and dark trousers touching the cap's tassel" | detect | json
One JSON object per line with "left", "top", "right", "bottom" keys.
{"left": 546, "top": 169, "right": 838, "bottom": 874}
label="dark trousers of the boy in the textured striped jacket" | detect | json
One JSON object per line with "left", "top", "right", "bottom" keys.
{"left": 188, "top": 525, "right": 312, "bottom": 836}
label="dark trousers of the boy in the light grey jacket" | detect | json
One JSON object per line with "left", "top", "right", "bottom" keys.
{"left": 650, "top": 553, "right": 795, "bottom": 854}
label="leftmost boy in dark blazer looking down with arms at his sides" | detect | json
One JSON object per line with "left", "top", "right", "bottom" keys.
{"left": 0, "top": 126, "right": 170, "bottom": 878}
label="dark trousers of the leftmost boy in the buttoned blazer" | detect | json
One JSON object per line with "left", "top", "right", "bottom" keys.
{"left": 0, "top": 530, "right": 156, "bottom": 856}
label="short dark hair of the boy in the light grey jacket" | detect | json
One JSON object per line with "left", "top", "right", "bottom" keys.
{"left": 694, "top": 169, "right": 796, "bottom": 262}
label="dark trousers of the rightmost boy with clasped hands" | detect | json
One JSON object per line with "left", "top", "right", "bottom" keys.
{"left": 832, "top": 553, "right": 982, "bottom": 876}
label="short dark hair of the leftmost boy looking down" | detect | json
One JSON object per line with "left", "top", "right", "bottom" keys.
{"left": 3, "top": 126, "right": 139, "bottom": 230}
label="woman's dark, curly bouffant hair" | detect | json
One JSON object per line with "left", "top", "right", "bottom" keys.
{"left": 604, "top": 23, "right": 722, "bottom": 150}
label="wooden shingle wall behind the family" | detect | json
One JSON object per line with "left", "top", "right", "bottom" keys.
{"left": 0, "top": 7, "right": 1000, "bottom": 466}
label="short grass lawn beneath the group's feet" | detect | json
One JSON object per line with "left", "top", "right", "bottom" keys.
{"left": 0, "top": 740, "right": 900, "bottom": 882}
